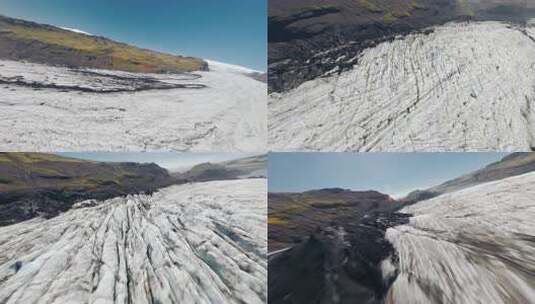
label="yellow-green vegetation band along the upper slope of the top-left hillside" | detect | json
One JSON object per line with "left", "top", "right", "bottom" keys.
{"left": 2, "top": 24, "right": 204, "bottom": 73}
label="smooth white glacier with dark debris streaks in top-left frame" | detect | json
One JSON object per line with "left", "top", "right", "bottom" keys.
{"left": 0, "top": 60, "right": 267, "bottom": 152}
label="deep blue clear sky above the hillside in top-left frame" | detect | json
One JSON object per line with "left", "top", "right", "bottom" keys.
{"left": 0, "top": 0, "right": 267, "bottom": 71}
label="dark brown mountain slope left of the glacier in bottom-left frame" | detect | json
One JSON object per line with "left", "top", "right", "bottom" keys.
{"left": 0, "top": 153, "right": 173, "bottom": 226}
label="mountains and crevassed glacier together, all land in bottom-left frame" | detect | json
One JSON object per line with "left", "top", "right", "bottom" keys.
{"left": 0, "top": 153, "right": 267, "bottom": 303}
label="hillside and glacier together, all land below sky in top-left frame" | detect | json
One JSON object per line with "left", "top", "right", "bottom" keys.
{"left": 0, "top": 17, "right": 267, "bottom": 152}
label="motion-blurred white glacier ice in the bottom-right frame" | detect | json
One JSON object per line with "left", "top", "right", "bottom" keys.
{"left": 385, "top": 173, "right": 535, "bottom": 304}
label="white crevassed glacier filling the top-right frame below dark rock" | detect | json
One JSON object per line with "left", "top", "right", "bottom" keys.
{"left": 268, "top": 22, "right": 535, "bottom": 151}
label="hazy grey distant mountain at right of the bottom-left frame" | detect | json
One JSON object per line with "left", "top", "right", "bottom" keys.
{"left": 174, "top": 154, "right": 267, "bottom": 182}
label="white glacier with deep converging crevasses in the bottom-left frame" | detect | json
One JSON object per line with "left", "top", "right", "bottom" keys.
{"left": 0, "top": 179, "right": 267, "bottom": 304}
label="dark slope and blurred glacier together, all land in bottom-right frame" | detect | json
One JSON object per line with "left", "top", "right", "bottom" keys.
{"left": 268, "top": 153, "right": 535, "bottom": 304}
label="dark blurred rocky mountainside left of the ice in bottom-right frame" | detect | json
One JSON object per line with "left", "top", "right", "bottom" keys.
{"left": 268, "top": 188, "right": 408, "bottom": 304}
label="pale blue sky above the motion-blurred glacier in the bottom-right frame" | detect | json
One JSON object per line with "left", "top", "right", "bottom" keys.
{"left": 268, "top": 153, "right": 507, "bottom": 197}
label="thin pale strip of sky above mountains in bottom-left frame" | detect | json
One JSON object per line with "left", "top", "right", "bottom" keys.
{"left": 57, "top": 152, "right": 254, "bottom": 171}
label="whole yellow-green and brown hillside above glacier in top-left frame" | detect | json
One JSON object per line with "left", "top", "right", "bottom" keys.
{"left": 0, "top": 16, "right": 208, "bottom": 73}
